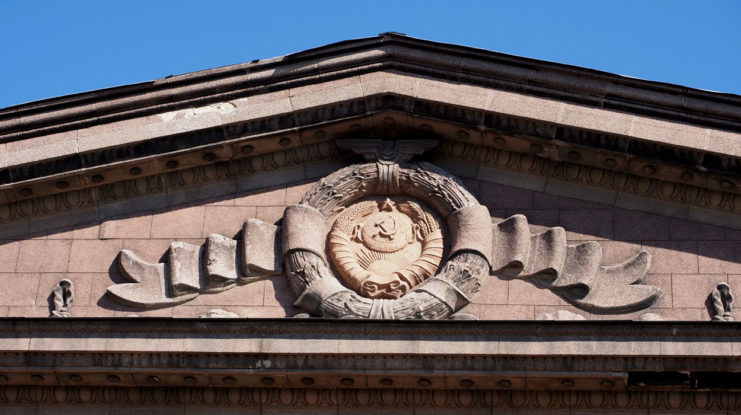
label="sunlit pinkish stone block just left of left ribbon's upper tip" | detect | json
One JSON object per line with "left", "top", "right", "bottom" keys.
{"left": 67, "top": 239, "right": 123, "bottom": 272}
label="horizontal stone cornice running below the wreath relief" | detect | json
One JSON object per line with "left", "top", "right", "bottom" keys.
{"left": 0, "top": 318, "right": 741, "bottom": 409}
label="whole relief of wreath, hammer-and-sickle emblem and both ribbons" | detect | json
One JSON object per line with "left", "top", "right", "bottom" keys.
{"left": 102, "top": 140, "right": 662, "bottom": 319}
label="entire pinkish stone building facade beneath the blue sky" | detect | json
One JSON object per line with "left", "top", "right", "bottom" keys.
{"left": 0, "top": 34, "right": 741, "bottom": 414}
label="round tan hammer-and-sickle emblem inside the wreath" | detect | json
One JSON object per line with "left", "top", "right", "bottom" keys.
{"left": 328, "top": 198, "right": 443, "bottom": 299}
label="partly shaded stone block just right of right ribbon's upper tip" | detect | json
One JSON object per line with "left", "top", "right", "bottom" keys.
{"left": 643, "top": 241, "right": 699, "bottom": 274}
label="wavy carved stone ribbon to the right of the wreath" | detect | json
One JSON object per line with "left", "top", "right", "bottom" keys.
{"left": 491, "top": 215, "right": 662, "bottom": 313}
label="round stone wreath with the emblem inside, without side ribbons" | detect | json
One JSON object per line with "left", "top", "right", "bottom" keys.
{"left": 282, "top": 161, "right": 492, "bottom": 319}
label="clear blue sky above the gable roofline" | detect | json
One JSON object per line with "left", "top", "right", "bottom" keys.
{"left": 0, "top": 0, "right": 741, "bottom": 108}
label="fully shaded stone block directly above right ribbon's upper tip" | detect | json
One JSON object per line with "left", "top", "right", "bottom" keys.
{"left": 615, "top": 209, "right": 671, "bottom": 241}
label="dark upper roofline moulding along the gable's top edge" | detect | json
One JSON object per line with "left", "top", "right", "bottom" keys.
{"left": 0, "top": 34, "right": 741, "bottom": 142}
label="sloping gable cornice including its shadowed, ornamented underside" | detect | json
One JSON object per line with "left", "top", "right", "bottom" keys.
{"left": 0, "top": 34, "right": 741, "bottom": 236}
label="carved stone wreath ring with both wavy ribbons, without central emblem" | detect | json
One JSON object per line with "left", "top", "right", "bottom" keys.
{"left": 108, "top": 163, "right": 662, "bottom": 319}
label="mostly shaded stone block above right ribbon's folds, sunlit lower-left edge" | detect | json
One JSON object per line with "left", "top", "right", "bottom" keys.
{"left": 560, "top": 209, "right": 614, "bottom": 241}
